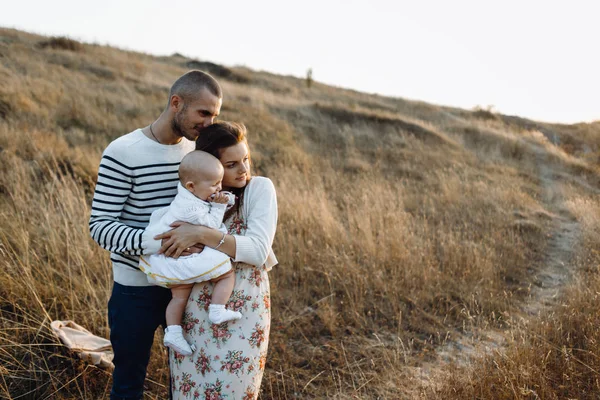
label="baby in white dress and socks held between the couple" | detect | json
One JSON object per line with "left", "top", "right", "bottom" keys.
{"left": 140, "top": 150, "right": 242, "bottom": 356}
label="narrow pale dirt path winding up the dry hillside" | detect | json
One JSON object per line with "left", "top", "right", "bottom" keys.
{"left": 414, "top": 144, "right": 580, "bottom": 398}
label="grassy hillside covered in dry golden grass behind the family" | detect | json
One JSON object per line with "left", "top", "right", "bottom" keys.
{"left": 0, "top": 29, "right": 600, "bottom": 399}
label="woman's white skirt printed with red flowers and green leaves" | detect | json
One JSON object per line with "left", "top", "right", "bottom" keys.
{"left": 169, "top": 263, "right": 271, "bottom": 400}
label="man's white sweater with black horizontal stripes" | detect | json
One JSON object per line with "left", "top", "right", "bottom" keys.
{"left": 90, "top": 129, "right": 195, "bottom": 286}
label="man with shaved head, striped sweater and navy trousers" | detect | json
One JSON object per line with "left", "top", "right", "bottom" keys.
{"left": 90, "top": 71, "right": 223, "bottom": 400}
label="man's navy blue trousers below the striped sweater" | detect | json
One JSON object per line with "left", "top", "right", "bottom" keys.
{"left": 108, "top": 282, "right": 171, "bottom": 400}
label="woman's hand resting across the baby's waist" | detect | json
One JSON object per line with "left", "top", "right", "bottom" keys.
{"left": 154, "top": 221, "right": 207, "bottom": 258}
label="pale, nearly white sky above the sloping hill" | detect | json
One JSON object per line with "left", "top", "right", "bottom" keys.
{"left": 0, "top": 0, "right": 600, "bottom": 123}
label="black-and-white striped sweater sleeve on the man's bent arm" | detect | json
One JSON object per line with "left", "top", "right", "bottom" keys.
{"left": 89, "top": 148, "right": 144, "bottom": 255}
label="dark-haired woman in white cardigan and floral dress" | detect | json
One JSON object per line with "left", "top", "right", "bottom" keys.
{"left": 157, "top": 122, "right": 277, "bottom": 400}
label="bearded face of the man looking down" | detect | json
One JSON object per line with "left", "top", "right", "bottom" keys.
{"left": 171, "top": 89, "right": 222, "bottom": 140}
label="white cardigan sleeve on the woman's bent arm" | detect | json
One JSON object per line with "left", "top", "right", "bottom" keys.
{"left": 234, "top": 177, "right": 277, "bottom": 266}
